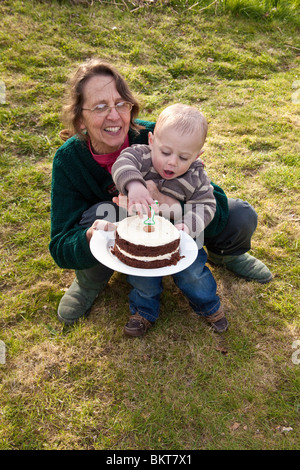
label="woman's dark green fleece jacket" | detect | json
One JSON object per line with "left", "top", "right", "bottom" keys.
{"left": 49, "top": 120, "right": 228, "bottom": 269}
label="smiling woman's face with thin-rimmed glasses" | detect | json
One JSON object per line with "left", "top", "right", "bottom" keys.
{"left": 81, "top": 75, "right": 130, "bottom": 154}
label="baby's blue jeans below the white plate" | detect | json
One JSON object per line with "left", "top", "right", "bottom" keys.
{"left": 127, "top": 248, "right": 220, "bottom": 322}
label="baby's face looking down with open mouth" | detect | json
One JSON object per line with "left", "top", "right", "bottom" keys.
{"left": 149, "top": 127, "right": 201, "bottom": 180}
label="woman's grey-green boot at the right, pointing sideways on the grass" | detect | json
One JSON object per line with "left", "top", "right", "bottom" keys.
{"left": 207, "top": 251, "right": 272, "bottom": 284}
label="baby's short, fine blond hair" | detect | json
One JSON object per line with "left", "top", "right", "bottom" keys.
{"left": 154, "top": 103, "right": 208, "bottom": 147}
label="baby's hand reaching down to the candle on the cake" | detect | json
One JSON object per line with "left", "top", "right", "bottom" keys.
{"left": 126, "top": 181, "right": 157, "bottom": 217}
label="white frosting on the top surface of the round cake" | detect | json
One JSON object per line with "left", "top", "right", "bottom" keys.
{"left": 118, "top": 215, "right": 180, "bottom": 246}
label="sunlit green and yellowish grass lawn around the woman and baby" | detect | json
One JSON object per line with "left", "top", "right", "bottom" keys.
{"left": 0, "top": 0, "right": 300, "bottom": 450}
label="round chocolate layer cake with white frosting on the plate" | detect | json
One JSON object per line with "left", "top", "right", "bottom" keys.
{"left": 112, "top": 215, "right": 181, "bottom": 269}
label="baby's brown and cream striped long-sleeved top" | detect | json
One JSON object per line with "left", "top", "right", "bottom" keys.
{"left": 111, "top": 144, "right": 216, "bottom": 238}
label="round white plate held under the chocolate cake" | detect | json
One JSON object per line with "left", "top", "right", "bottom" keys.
{"left": 90, "top": 230, "right": 198, "bottom": 277}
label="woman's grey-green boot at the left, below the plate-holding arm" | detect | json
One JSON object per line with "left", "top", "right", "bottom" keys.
{"left": 57, "top": 279, "right": 100, "bottom": 325}
